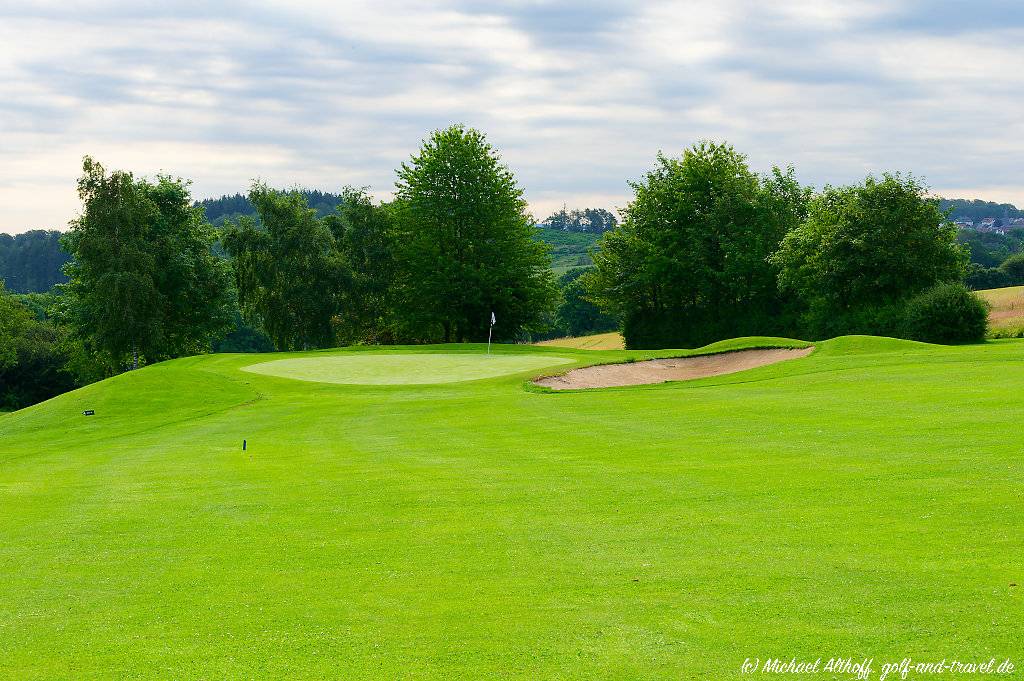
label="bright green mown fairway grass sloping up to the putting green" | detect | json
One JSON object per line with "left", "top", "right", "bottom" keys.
{"left": 0, "top": 338, "right": 1024, "bottom": 679}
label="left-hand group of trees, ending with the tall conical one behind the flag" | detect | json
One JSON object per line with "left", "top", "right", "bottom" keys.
{"left": 0, "top": 126, "right": 558, "bottom": 406}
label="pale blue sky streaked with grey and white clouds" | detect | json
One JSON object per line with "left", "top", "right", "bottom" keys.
{"left": 0, "top": 0, "right": 1024, "bottom": 233}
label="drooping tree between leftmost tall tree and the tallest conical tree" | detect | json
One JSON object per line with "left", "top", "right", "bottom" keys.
{"left": 223, "top": 182, "right": 349, "bottom": 350}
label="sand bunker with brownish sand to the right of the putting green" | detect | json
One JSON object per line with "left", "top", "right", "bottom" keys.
{"left": 535, "top": 347, "right": 814, "bottom": 390}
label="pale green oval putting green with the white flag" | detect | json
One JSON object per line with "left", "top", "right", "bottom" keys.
{"left": 245, "top": 353, "right": 574, "bottom": 385}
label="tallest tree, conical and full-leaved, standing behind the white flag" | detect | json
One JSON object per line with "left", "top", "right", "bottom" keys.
{"left": 394, "top": 125, "right": 556, "bottom": 342}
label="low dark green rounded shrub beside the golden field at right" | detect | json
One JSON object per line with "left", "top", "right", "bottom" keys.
{"left": 903, "top": 283, "right": 988, "bottom": 344}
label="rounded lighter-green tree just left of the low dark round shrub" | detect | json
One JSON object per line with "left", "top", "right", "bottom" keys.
{"left": 773, "top": 174, "right": 967, "bottom": 337}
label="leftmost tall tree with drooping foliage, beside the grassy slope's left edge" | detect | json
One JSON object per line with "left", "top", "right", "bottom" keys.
{"left": 61, "top": 157, "right": 231, "bottom": 370}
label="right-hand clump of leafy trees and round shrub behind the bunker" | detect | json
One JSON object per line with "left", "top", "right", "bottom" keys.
{"left": 584, "top": 142, "right": 987, "bottom": 348}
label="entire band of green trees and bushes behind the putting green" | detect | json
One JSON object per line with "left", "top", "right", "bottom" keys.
{"left": 0, "top": 126, "right": 999, "bottom": 406}
